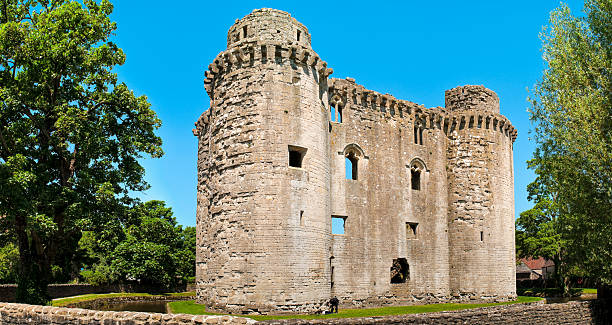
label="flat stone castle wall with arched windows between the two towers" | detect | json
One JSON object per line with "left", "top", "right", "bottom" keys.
{"left": 330, "top": 78, "right": 449, "bottom": 306}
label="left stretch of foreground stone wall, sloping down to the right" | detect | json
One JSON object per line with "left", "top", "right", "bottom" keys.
{"left": 0, "top": 303, "right": 255, "bottom": 325}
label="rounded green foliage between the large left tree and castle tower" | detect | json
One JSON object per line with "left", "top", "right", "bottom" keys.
{"left": 81, "top": 201, "right": 195, "bottom": 288}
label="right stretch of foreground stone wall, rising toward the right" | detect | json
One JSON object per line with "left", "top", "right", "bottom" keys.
{"left": 260, "top": 300, "right": 612, "bottom": 325}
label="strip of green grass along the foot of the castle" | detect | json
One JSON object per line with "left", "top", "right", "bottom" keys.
{"left": 168, "top": 296, "right": 542, "bottom": 320}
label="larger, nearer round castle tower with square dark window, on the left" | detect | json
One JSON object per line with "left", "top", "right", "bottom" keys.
{"left": 194, "top": 9, "right": 331, "bottom": 313}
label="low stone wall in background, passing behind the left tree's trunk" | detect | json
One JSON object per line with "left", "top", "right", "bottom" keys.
{"left": 0, "top": 283, "right": 194, "bottom": 302}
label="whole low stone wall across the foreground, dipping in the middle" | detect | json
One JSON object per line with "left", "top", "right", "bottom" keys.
{"left": 0, "top": 300, "right": 612, "bottom": 325}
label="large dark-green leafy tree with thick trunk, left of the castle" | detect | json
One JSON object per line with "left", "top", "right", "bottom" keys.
{"left": 0, "top": 0, "right": 163, "bottom": 304}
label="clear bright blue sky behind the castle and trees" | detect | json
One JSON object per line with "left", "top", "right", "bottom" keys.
{"left": 112, "top": 0, "right": 582, "bottom": 226}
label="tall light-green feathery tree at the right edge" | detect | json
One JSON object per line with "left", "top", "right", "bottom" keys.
{"left": 517, "top": 0, "right": 612, "bottom": 290}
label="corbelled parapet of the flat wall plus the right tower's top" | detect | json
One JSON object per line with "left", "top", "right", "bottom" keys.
{"left": 329, "top": 78, "right": 517, "bottom": 141}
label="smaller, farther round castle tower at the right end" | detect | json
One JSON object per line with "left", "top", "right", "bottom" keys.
{"left": 445, "top": 86, "right": 516, "bottom": 300}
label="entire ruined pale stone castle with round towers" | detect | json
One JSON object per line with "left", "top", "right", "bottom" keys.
{"left": 194, "top": 9, "right": 517, "bottom": 313}
